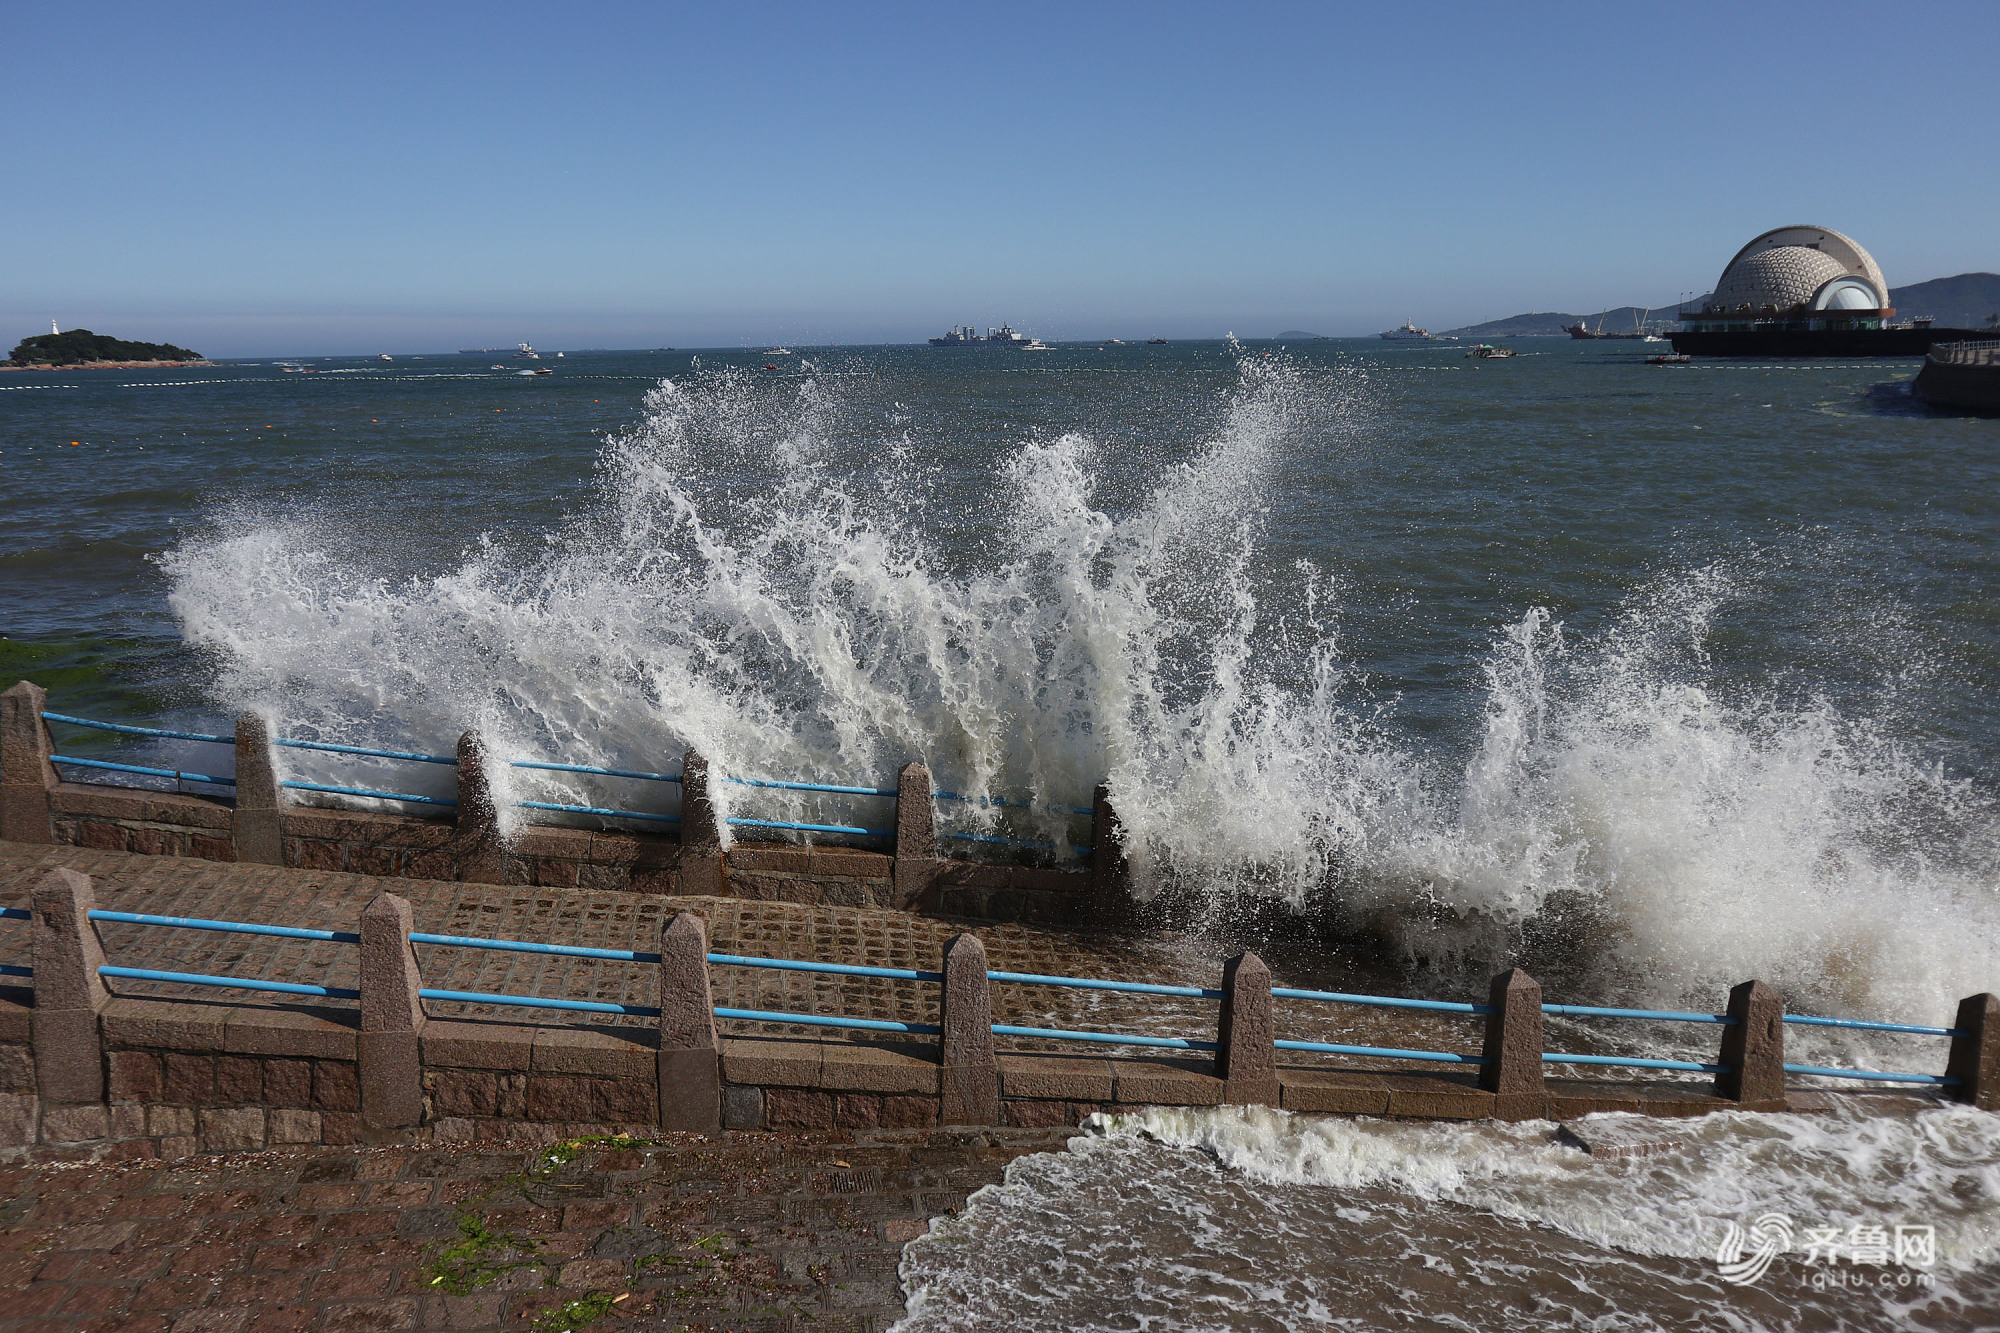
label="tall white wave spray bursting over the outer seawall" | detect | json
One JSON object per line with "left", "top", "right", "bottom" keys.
{"left": 164, "top": 356, "right": 2000, "bottom": 1020}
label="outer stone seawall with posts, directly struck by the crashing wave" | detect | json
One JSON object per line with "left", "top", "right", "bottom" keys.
{"left": 0, "top": 681, "right": 1128, "bottom": 925}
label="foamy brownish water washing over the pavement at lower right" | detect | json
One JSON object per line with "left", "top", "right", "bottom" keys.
{"left": 898, "top": 1107, "right": 2000, "bottom": 1333}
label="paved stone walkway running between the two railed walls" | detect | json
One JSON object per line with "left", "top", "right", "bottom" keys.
{"left": 0, "top": 843, "right": 1480, "bottom": 1067}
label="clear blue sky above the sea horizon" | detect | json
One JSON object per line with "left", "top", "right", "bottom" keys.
{"left": 0, "top": 0, "right": 2000, "bottom": 356}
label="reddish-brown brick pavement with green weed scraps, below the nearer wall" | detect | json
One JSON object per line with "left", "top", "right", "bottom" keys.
{"left": 0, "top": 1129, "right": 1066, "bottom": 1333}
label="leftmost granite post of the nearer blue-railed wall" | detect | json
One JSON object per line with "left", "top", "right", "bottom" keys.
{"left": 28, "top": 871, "right": 110, "bottom": 1107}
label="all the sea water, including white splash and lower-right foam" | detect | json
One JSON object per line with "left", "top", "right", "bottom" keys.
{"left": 0, "top": 340, "right": 2000, "bottom": 1327}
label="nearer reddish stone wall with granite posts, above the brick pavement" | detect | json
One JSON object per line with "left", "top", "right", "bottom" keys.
{"left": 0, "top": 856, "right": 2000, "bottom": 1159}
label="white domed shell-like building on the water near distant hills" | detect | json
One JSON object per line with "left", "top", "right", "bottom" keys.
{"left": 1674, "top": 226, "right": 1946, "bottom": 356}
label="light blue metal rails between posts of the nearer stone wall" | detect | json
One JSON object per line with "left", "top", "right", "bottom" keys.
{"left": 0, "top": 888, "right": 1966, "bottom": 1087}
